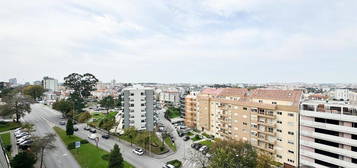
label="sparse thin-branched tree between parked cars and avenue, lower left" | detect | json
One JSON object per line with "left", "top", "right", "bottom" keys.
{"left": 31, "top": 133, "right": 56, "bottom": 168}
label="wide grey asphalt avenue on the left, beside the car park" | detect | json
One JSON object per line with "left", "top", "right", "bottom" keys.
{"left": 23, "top": 104, "right": 80, "bottom": 168}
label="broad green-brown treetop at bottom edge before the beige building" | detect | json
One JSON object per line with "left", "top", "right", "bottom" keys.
{"left": 208, "top": 140, "right": 257, "bottom": 168}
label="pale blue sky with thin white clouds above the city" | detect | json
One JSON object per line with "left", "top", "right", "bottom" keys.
{"left": 0, "top": 0, "right": 357, "bottom": 83}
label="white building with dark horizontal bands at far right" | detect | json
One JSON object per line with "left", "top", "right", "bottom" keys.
{"left": 300, "top": 100, "right": 357, "bottom": 168}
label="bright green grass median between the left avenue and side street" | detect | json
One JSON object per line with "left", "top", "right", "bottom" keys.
{"left": 53, "top": 127, "right": 134, "bottom": 168}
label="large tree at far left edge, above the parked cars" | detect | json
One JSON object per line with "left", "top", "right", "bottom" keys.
{"left": 0, "top": 93, "right": 32, "bottom": 122}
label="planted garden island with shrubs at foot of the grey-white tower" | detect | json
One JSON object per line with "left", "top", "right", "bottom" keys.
{"left": 118, "top": 128, "right": 169, "bottom": 155}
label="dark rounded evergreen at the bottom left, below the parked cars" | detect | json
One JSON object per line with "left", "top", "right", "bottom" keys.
{"left": 11, "top": 151, "right": 36, "bottom": 168}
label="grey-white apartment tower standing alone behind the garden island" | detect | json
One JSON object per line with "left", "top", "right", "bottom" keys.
{"left": 122, "top": 85, "right": 154, "bottom": 131}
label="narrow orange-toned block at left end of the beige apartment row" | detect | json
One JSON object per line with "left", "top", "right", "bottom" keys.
{"left": 184, "top": 92, "right": 198, "bottom": 128}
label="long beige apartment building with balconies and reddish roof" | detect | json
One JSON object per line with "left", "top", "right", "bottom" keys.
{"left": 187, "top": 88, "right": 302, "bottom": 167}
